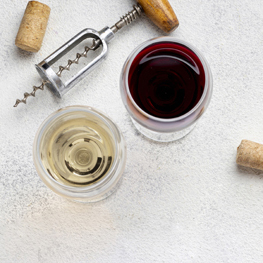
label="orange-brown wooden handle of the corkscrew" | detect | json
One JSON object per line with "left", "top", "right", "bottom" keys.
{"left": 136, "top": 0, "right": 179, "bottom": 33}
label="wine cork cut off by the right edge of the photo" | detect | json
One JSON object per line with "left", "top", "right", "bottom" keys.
{"left": 236, "top": 140, "right": 263, "bottom": 170}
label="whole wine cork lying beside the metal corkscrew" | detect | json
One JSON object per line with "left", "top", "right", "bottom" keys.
{"left": 15, "top": 1, "right": 50, "bottom": 52}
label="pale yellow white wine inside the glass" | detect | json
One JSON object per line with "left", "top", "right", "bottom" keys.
{"left": 40, "top": 111, "right": 116, "bottom": 187}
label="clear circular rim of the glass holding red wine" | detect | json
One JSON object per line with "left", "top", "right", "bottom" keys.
{"left": 124, "top": 36, "right": 211, "bottom": 123}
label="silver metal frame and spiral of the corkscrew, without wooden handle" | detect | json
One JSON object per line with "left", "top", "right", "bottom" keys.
{"left": 14, "top": 5, "right": 142, "bottom": 107}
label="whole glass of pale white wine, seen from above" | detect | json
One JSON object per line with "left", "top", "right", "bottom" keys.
{"left": 33, "top": 106, "right": 126, "bottom": 202}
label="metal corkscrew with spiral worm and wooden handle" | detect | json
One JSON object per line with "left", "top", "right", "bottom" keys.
{"left": 14, "top": 0, "right": 179, "bottom": 107}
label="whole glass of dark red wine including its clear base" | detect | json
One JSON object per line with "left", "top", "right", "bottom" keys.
{"left": 120, "top": 37, "right": 213, "bottom": 142}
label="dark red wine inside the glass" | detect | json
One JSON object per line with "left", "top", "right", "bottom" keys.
{"left": 128, "top": 42, "right": 205, "bottom": 118}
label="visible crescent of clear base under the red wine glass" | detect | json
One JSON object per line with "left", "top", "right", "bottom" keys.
{"left": 130, "top": 117, "right": 196, "bottom": 142}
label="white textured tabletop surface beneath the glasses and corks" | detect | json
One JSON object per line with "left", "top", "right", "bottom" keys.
{"left": 0, "top": 0, "right": 263, "bottom": 263}
